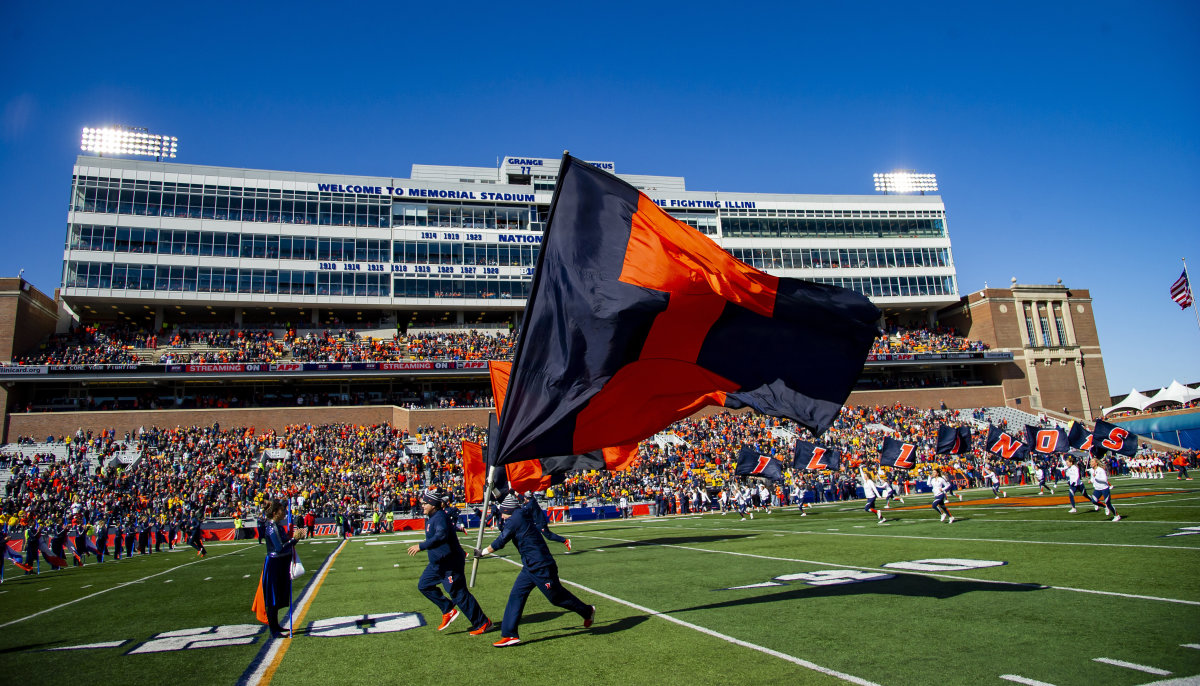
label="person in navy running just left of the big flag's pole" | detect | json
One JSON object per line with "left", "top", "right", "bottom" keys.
{"left": 408, "top": 487, "right": 492, "bottom": 636}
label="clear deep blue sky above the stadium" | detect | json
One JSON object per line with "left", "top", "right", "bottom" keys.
{"left": 0, "top": 1, "right": 1200, "bottom": 393}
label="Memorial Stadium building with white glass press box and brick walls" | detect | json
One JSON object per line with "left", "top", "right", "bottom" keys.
{"left": 0, "top": 156, "right": 1106, "bottom": 436}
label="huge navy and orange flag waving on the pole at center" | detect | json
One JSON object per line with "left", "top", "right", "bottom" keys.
{"left": 490, "top": 155, "right": 880, "bottom": 464}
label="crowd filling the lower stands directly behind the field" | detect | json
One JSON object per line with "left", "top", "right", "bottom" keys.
{"left": 7, "top": 404, "right": 1195, "bottom": 539}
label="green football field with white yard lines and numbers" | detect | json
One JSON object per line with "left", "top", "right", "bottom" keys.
{"left": 0, "top": 479, "right": 1200, "bottom": 686}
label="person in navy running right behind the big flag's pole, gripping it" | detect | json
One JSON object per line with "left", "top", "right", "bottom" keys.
{"left": 475, "top": 492, "right": 596, "bottom": 648}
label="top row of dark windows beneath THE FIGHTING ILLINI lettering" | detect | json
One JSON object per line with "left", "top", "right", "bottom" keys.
{"left": 721, "top": 216, "right": 946, "bottom": 239}
